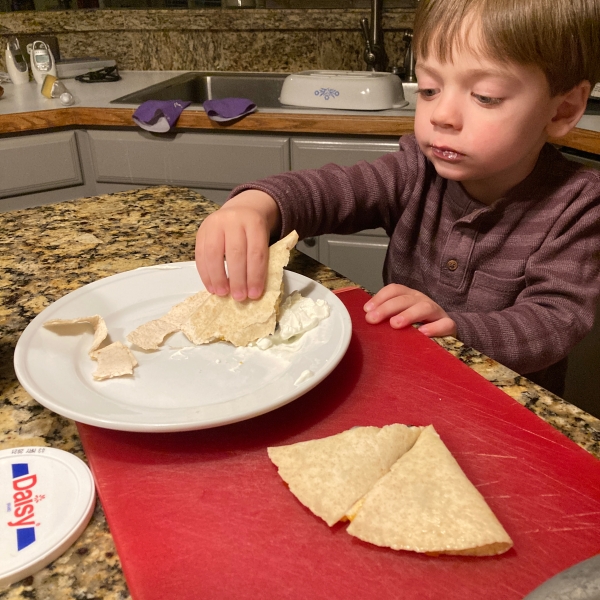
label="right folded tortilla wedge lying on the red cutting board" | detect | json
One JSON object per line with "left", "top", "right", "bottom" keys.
{"left": 347, "top": 425, "right": 513, "bottom": 556}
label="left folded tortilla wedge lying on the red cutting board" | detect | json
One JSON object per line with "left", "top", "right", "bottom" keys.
{"left": 267, "top": 424, "right": 422, "bottom": 526}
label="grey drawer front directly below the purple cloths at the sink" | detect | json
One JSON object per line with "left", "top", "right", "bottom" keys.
{"left": 88, "top": 131, "right": 290, "bottom": 190}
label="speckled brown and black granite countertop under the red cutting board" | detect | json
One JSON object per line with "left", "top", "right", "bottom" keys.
{"left": 0, "top": 187, "right": 600, "bottom": 600}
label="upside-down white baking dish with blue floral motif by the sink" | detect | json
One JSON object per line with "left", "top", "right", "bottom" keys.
{"left": 279, "top": 71, "right": 408, "bottom": 110}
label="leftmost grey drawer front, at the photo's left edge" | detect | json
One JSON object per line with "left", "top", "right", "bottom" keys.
{"left": 0, "top": 131, "right": 83, "bottom": 198}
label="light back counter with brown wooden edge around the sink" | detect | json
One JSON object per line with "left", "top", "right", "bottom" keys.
{"left": 0, "top": 71, "right": 600, "bottom": 154}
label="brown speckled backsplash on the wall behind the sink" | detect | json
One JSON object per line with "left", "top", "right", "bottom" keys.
{"left": 0, "top": 8, "right": 414, "bottom": 72}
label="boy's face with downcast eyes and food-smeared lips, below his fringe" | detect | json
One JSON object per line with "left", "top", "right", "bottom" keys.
{"left": 415, "top": 36, "right": 560, "bottom": 204}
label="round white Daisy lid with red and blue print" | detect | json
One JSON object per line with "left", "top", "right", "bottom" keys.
{"left": 0, "top": 446, "right": 96, "bottom": 585}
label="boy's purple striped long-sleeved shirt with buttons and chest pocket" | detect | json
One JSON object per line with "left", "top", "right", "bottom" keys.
{"left": 233, "top": 135, "right": 600, "bottom": 382}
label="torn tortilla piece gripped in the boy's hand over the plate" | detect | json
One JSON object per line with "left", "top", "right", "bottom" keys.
{"left": 181, "top": 231, "right": 298, "bottom": 346}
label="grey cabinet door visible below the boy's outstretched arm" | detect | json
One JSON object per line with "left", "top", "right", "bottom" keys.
{"left": 319, "top": 234, "right": 388, "bottom": 293}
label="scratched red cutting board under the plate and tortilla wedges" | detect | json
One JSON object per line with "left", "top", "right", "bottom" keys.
{"left": 79, "top": 290, "right": 600, "bottom": 600}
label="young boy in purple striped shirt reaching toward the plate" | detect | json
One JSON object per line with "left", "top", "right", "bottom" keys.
{"left": 196, "top": 0, "right": 600, "bottom": 393}
